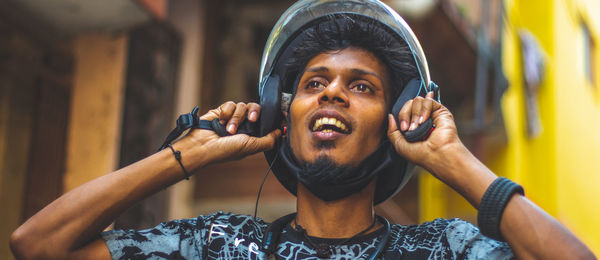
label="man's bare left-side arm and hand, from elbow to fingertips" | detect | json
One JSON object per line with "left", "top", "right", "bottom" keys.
{"left": 10, "top": 102, "right": 280, "bottom": 259}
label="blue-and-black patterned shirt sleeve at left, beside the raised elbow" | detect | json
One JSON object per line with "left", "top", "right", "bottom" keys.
{"left": 101, "top": 217, "right": 204, "bottom": 259}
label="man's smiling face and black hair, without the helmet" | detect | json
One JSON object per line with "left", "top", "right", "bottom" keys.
{"left": 284, "top": 15, "right": 416, "bottom": 166}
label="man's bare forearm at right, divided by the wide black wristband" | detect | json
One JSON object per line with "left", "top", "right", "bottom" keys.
{"left": 432, "top": 145, "right": 594, "bottom": 259}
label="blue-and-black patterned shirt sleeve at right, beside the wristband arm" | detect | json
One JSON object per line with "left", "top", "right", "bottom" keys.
{"left": 444, "top": 219, "right": 513, "bottom": 259}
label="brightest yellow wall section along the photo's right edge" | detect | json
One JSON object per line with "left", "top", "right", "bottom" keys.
{"left": 552, "top": 0, "right": 600, "bottom": 255}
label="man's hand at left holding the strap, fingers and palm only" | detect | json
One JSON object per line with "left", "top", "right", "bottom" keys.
{"left": 185, "top": 101, "right": 281, "bottom": 165}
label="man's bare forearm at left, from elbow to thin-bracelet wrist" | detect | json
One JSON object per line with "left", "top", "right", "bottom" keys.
{"left": 11, "top": 139, "right": 204, "bottom": 258}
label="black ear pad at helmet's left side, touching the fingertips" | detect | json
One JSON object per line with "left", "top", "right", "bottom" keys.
{"left": 259, "top": 75, "right": 282, "bottom": 136}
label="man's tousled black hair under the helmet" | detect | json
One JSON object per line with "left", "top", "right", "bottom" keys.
{"left": 284, "top": 14, "right": 418, "bottom": 104}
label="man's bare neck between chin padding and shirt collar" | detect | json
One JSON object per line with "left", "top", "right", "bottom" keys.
{"left": 296, "top": 179, "right": 381, "bottom": 238}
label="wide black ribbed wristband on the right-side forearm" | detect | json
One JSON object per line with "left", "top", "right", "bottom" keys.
{"left": 477, "top": 177, "right": 525, "bottom": 241}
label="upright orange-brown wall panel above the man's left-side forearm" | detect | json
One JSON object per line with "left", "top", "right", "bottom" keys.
{"left": 64, "top": 34, "right": 127, "bottom": 192}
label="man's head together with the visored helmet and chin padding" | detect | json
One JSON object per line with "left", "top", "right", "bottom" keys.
{"left": 259, "top": 0, "right": 430, "bottom": 204}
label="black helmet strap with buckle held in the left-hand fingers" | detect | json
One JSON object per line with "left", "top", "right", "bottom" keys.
{"left": 159, "top": 106, "right": 258, "bottom": 151}
